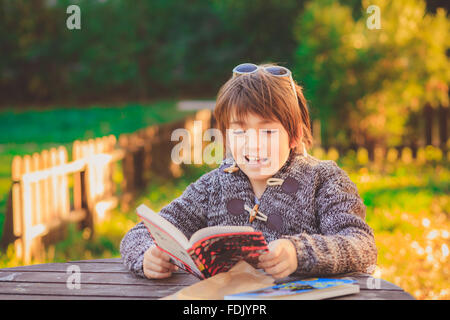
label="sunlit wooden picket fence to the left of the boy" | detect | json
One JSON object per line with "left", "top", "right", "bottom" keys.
{"left": 2, "top": 110, "right": 211, "bottom": 264}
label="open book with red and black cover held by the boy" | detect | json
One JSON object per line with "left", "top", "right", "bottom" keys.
{"left": 137, "top": 204, "right": 268, "bottom": 279}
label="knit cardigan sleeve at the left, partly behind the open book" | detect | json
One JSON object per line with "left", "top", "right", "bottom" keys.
{"left": 120, "top": 172, "right": 213, "bottom": 277}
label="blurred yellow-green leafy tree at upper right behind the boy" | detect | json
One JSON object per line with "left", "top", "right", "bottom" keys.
{"left": 295, "top": 0, "right": 450, "bottom": 154}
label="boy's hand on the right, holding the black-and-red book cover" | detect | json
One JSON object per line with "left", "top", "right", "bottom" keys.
{"left": 258, "top": 239, "right": 298, "bottom": 279}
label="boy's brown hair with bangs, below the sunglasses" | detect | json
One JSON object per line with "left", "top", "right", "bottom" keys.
{"left": 214, "top": 64, "right": 313, "bottom": 153}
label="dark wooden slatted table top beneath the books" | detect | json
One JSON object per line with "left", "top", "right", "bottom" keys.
{"left": 0, "top": 259, "right": 414, "bottom": 300}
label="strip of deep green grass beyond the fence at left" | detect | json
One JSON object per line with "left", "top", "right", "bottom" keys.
{"left": 0, "top": 101, "right": 192, "bottom": 144}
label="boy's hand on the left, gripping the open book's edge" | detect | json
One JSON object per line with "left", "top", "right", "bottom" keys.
{"left": 143, "top": 245, "right": 178, "bottom": 279}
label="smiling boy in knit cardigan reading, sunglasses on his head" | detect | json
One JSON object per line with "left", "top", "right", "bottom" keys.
{"left": 120, "top": 63, "right": 377, "bottom": 279}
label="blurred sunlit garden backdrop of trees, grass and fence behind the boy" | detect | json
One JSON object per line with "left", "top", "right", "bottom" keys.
{"left": 0, "top": 0, "right": 450, "bottom": 299}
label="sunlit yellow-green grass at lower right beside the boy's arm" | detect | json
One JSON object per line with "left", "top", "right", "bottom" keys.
{"left": 347, "top": 150, "right": 450, "bottom": 299}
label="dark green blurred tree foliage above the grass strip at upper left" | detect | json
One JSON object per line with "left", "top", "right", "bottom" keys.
{"left": 0, "top": 0, "right": 303, "bottom": 104}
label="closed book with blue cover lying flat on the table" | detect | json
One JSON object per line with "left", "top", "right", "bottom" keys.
{"left": 224, "top": 278, "right": 359, "bottom": 300}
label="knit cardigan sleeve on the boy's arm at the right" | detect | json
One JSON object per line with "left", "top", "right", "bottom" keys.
{"left": 283, "top": 161, "right": 377, "bottom": 275}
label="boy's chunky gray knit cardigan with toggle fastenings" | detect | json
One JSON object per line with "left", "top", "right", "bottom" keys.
{"left": 120, "top": 152, "right": 377, "bottom": 277}
